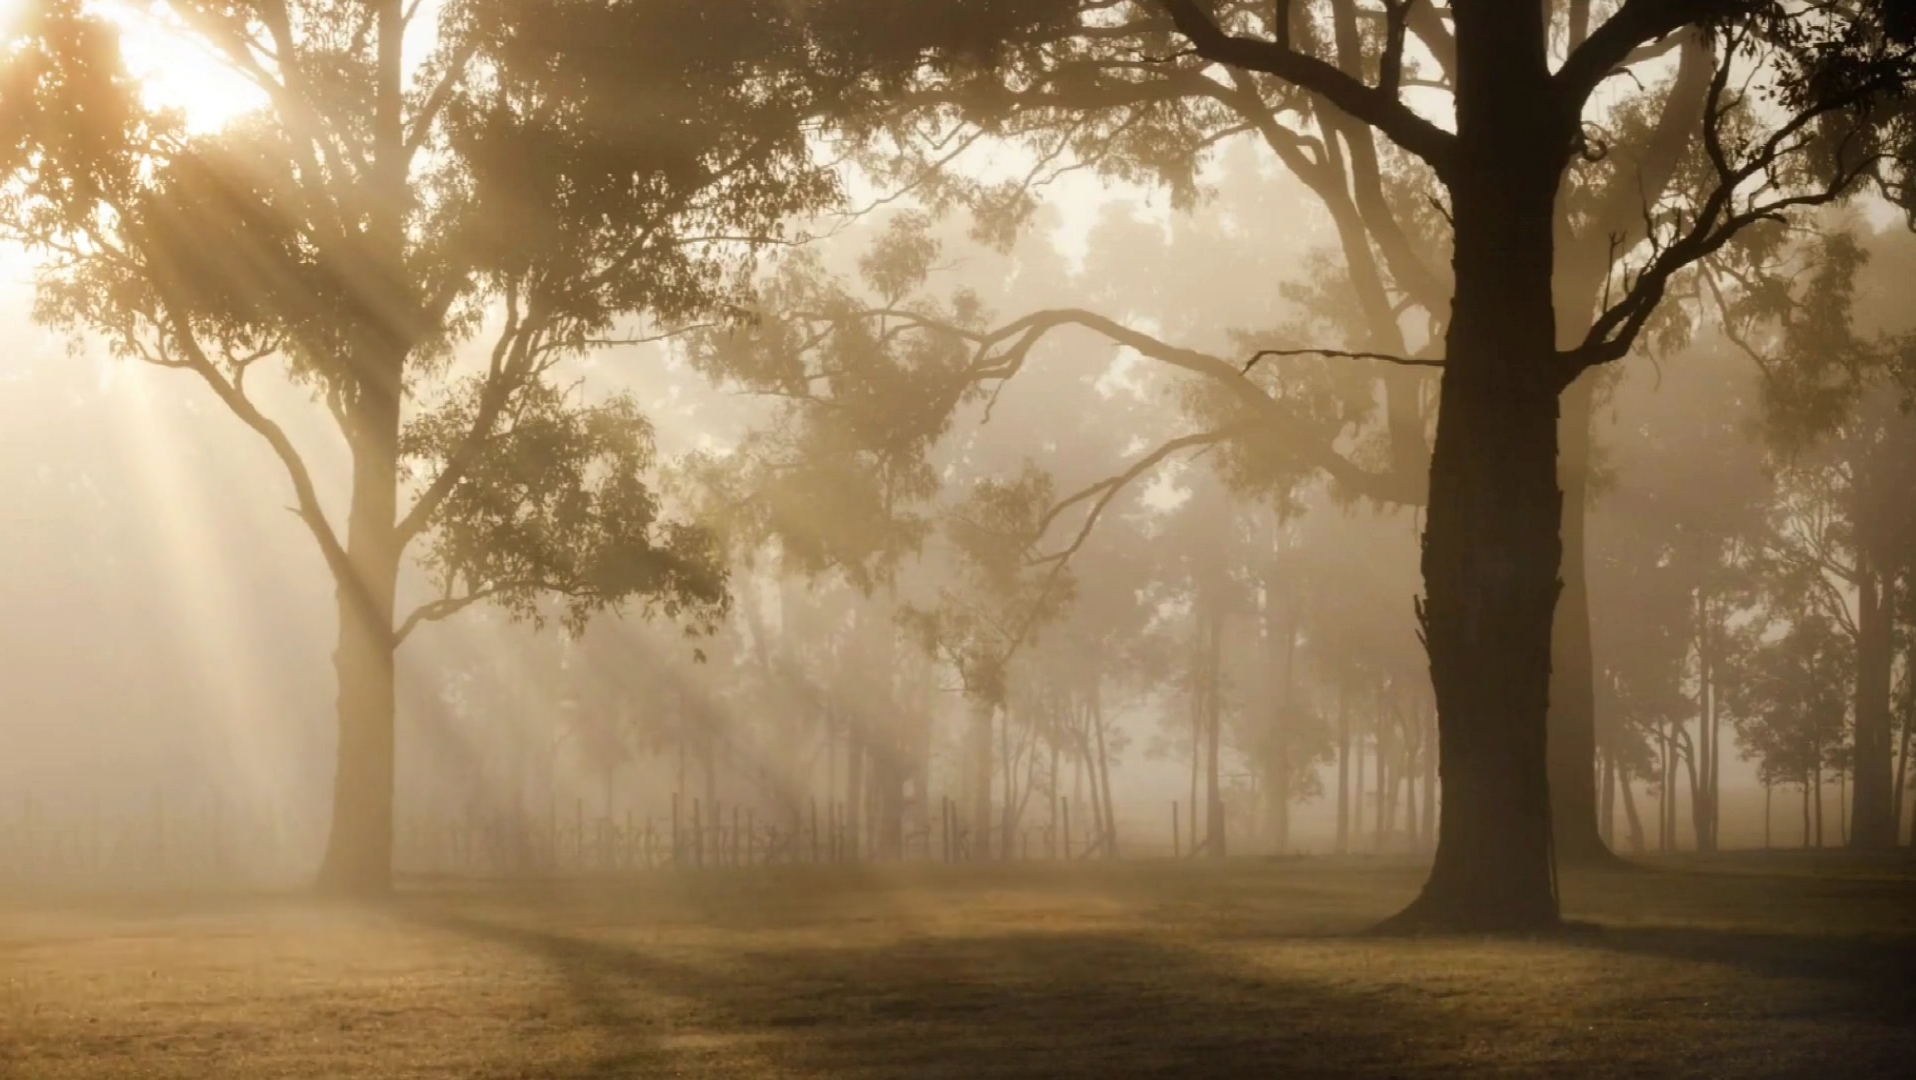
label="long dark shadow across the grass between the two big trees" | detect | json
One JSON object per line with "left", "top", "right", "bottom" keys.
{"left": 412, "top": 910, "right": 1448, "bottom": 1080}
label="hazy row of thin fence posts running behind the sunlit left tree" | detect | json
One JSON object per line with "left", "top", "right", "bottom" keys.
{"left": 0, "top": 793, "right": 1171, "bottom": 887}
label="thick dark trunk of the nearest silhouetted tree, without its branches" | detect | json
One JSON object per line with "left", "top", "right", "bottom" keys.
{"left": 1391, "top": 0, "right": 1563, "bottom": 931}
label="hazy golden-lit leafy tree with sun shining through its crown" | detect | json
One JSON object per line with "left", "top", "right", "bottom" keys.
{"left": 4, "top": 0, "right": 858, "bottom": 894}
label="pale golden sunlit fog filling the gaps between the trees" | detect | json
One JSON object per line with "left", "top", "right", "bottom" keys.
{"left": 0, "top": 138, "right": 1916, "bottom": 881}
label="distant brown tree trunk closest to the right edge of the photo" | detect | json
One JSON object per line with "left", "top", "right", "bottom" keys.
{"left": 1849, "top": 559, "right": 1899, "bottom": 848}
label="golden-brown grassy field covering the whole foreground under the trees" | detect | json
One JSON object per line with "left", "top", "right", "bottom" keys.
{"left": 0, "top": 856, "right": 1916, "bottom": 1080}
